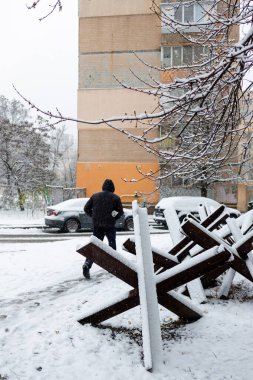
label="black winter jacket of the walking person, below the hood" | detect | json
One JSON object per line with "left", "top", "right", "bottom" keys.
{"left": 84, "top": 190, "right": 124, "bottom": 228}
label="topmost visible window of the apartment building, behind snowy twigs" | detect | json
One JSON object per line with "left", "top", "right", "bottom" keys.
{"left": 161, "top": 0, "right": 213, "bottom": 33}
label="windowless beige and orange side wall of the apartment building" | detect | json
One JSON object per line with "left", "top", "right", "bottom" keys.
{"left": 77, "top": 0, "right": 161, "bottom": 204}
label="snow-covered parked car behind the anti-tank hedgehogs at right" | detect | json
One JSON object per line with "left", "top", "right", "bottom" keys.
{"left": 153, "top": 196, "right": 241, "bottom": 227}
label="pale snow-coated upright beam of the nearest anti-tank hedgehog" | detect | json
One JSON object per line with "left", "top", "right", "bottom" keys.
{"left": 133, "top": 201, "right": 163, "bottom": 371}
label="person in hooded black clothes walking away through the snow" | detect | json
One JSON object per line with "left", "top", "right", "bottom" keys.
{"left": 83, "top": 179, "right": 124, "bottom": 279}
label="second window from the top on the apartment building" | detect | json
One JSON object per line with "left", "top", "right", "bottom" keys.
{"left": 161, "top": 45, "right": 210, "bottom": 68}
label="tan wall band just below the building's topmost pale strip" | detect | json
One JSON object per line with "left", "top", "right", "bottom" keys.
{"left": 79, "top": 14, "right": 161, "bottom": 53}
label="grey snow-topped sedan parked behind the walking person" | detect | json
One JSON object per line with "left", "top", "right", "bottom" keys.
{"left": 45, "top": 198, "right": 134, "bottom": 232}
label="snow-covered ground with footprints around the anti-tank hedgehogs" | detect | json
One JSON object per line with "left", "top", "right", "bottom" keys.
{"left": 0, "top": 212, "right": 253, "bottom": 380}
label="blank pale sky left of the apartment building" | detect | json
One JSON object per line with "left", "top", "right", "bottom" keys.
{"left": 0, "top": 0, "right": 78, "bottom": 134}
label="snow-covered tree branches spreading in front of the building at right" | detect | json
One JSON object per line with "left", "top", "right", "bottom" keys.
{"left": 21, "top": 0, "right": 253, "bottom": 193}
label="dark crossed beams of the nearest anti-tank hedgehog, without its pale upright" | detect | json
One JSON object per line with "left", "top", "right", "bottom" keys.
{"left": 77, "top": 237, "right": 231, "bottom": 324}
